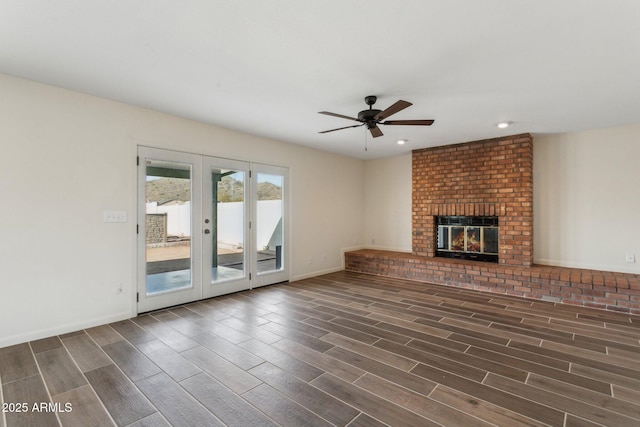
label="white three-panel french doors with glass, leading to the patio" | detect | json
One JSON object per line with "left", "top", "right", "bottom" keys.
{"left": 138, "top": 147, "right": 289, "bottom": 313}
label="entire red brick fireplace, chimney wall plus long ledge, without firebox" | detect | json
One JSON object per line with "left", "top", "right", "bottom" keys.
{"left": 345, "top": 134, "right": 640, "bottom": 314}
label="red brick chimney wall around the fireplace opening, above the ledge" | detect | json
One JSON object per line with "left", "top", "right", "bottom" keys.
{"left": 412, "top": 134, "right": 533, "bottom": 266}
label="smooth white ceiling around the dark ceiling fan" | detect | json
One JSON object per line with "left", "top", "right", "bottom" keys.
{"left": 0, "top": 0, "right": 640, "bottom": 159}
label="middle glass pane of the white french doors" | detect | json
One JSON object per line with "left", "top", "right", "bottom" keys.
{"left": 208, "top": 168, "right": 247, "bottom": 284}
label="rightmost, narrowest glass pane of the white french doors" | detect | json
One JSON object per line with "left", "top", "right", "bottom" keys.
{"left": 256, "top": 173, "right": 286, "bottom": 274}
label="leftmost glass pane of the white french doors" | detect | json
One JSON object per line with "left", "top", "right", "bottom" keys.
{"left": 145, "top": 160, "right": 193, "bottom": 295}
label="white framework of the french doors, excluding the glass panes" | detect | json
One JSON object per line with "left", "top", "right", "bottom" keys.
{"left": 135, "top": 149, "right": 292, "bottom": 313}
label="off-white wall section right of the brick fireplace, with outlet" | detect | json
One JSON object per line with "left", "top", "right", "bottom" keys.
{"left": 533, "top": 125, "right": 640, "bottom": 273}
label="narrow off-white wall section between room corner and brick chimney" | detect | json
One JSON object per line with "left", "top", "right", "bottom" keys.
{"left": 364, "top": 153, "right": 412, "bottom": 252}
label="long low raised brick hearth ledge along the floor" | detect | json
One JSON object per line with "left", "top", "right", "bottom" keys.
{"left": 345, "top": 249, "right": 640, "bottom": 315}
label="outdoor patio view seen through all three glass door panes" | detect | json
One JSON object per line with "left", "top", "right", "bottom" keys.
{"left": 145, "top": 161, "right": 283, "bottom": 295}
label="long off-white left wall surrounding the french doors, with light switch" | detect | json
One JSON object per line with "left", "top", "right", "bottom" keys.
{"left": 0, "top": 75, "right": 364, "bottom": 347}
